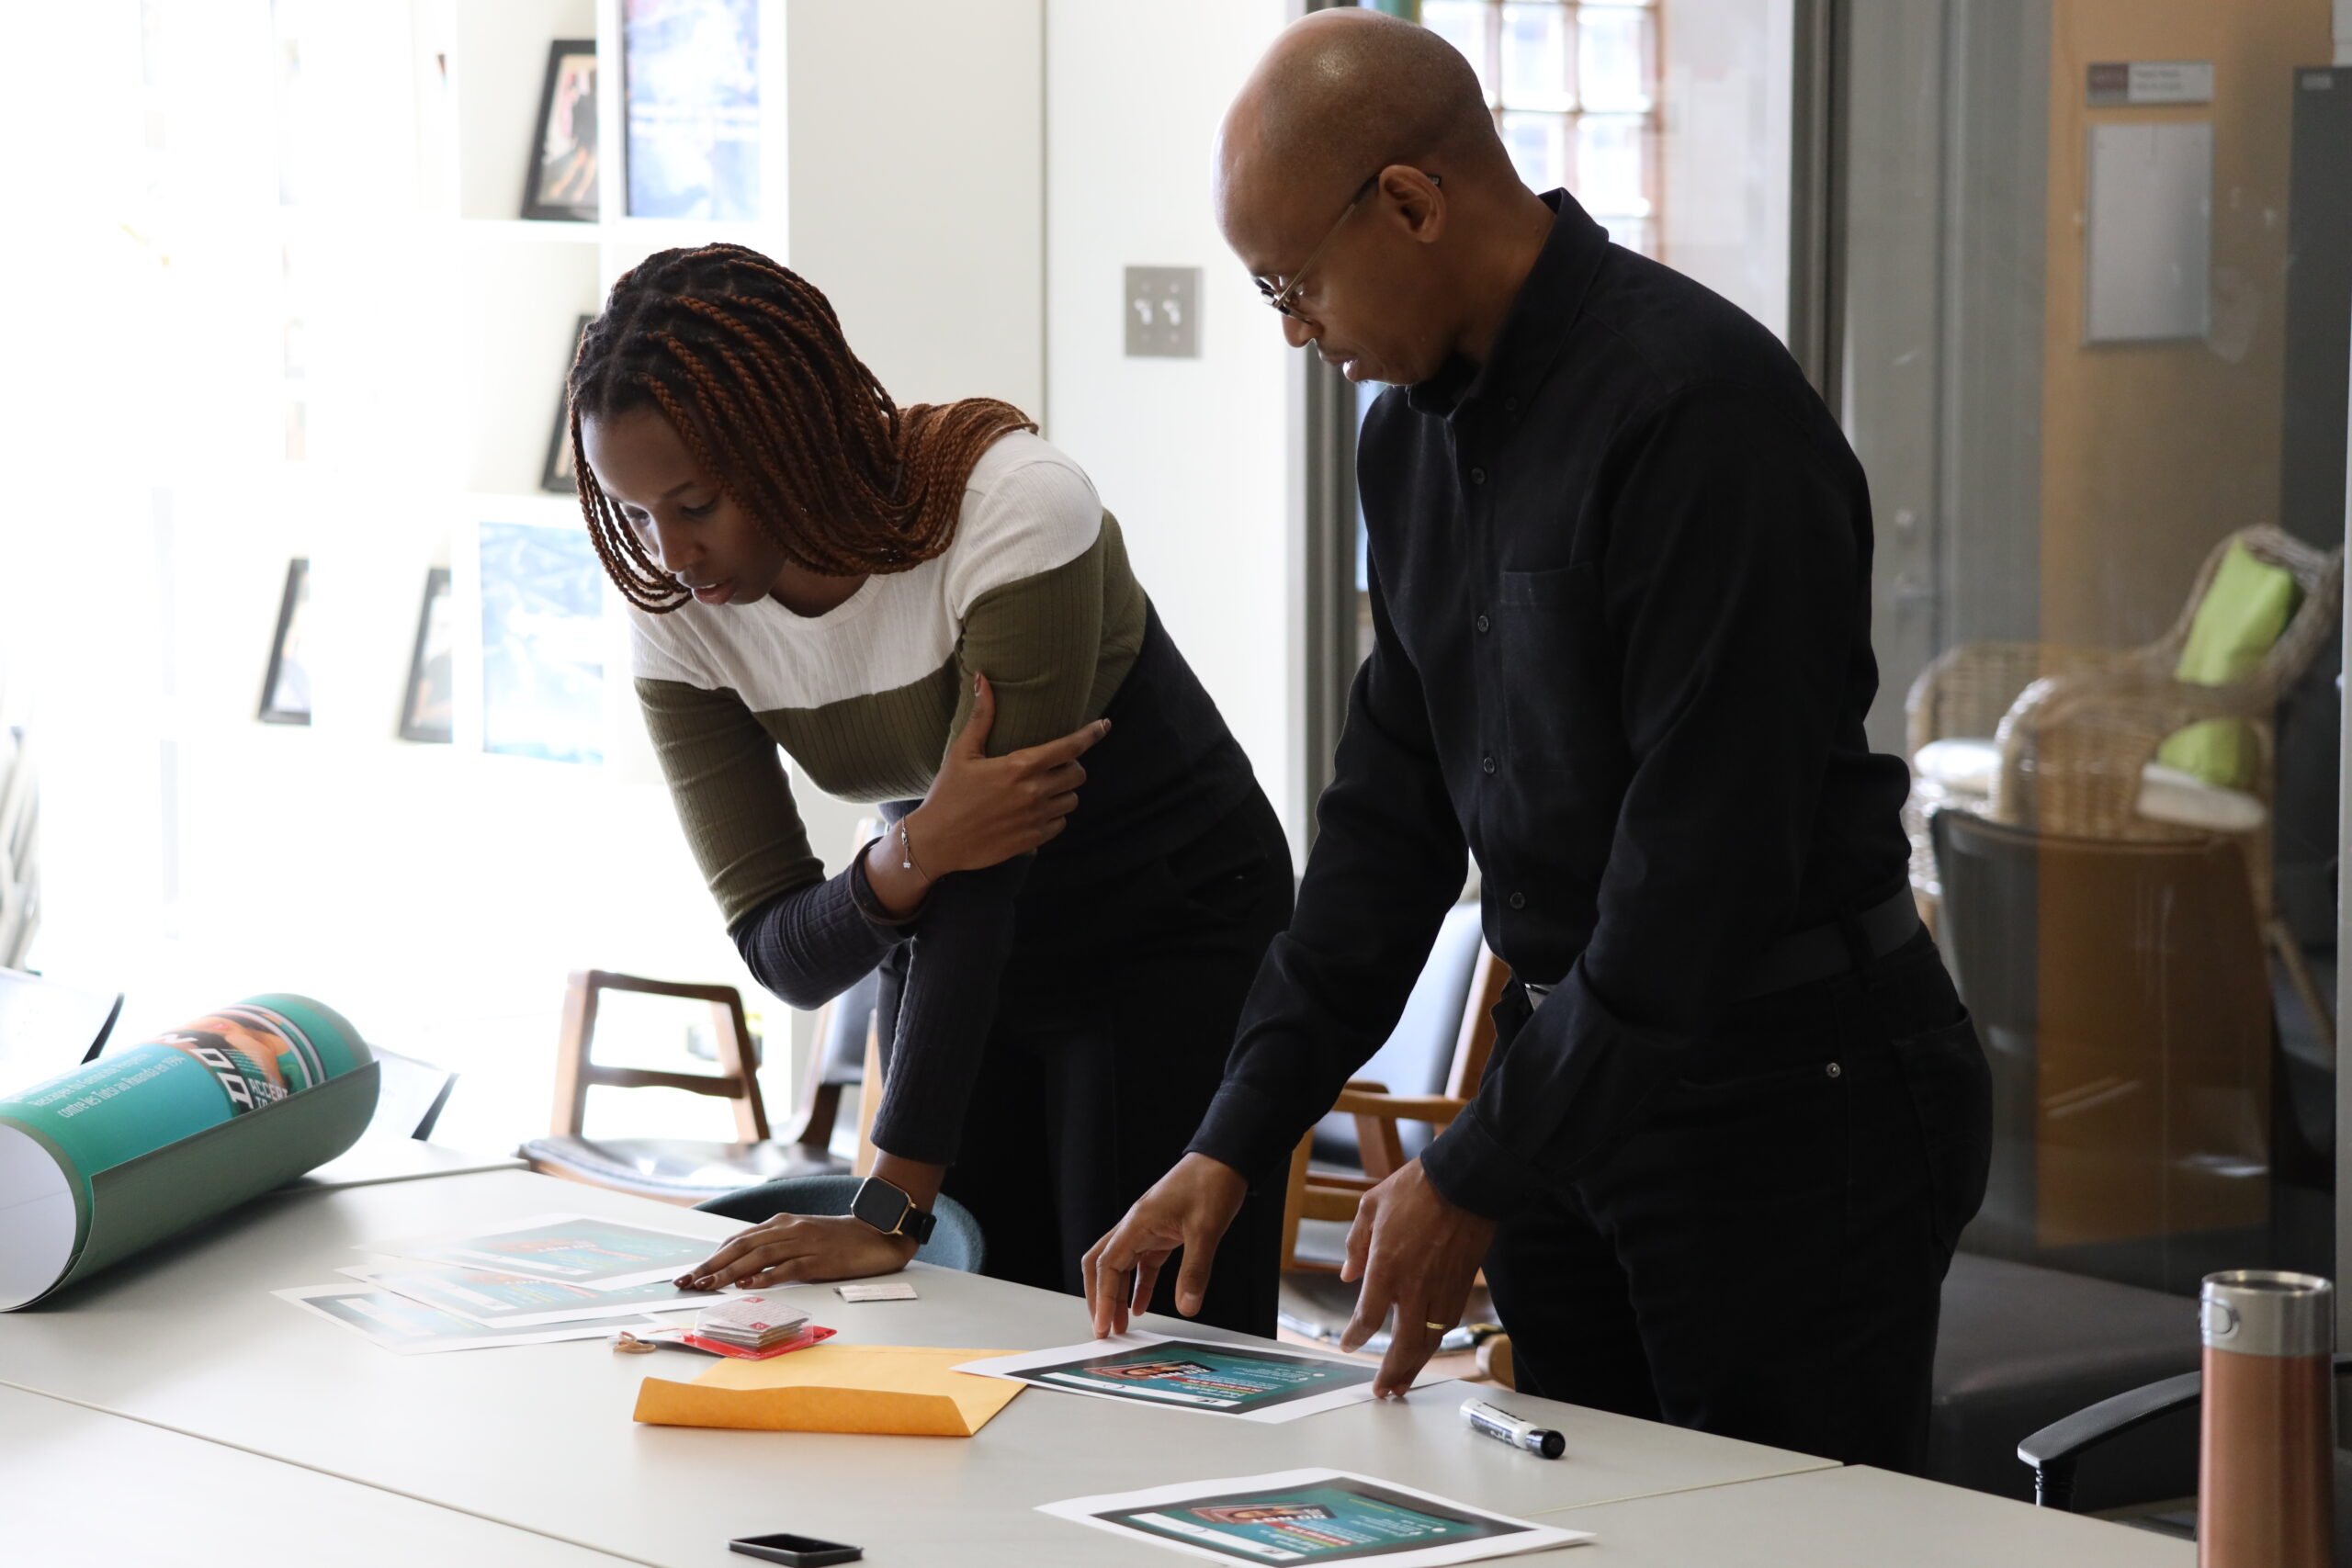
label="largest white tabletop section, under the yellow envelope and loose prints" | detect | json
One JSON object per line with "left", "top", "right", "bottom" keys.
{"left": 0, "top": 1170, "right": 1827, "bottom": 1568}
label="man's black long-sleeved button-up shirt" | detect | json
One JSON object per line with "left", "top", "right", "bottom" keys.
{"left": 1193, "top": 193, "right": 1907, "bottom": 1215}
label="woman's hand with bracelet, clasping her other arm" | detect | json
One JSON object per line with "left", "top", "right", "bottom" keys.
{"left": 865, "top": 674, "right": 1110, "bottom": 915}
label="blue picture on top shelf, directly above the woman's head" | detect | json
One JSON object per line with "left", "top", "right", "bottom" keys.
{"left": 621, "top": 0, "right": 760, "bottom": 221}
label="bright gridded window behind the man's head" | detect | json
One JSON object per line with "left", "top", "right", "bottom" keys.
{"left": 1420, "top": 0, "right": 1660, "bottom": 256}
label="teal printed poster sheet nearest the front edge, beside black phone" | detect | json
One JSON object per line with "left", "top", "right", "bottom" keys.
{"left": 1037, "top": 1470, "right": 1592, "bottom": 1568}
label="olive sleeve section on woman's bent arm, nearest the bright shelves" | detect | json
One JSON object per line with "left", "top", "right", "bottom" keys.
{"left": 638, "top": 677, "right": 826, "bottom": 929}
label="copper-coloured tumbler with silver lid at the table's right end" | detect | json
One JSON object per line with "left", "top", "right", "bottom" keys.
{"left": 2197, "top": 1269, "right": 2335, "bottom": 1568}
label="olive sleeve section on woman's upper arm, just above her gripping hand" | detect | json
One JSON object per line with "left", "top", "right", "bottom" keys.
{"left": 948, "top": 513, "right": 1146, "bottom": 757}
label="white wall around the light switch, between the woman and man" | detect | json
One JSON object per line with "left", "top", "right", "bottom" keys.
{"left": 1045, "top": 0, "right": 1303, "bottom": 840}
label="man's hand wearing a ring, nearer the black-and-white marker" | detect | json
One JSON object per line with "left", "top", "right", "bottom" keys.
{"left": 1336, "top": 1159, "right": 1494, "bottom": 1399}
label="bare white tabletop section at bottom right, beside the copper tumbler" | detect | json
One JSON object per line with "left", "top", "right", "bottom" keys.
{"left": 1543, "top": 1464, "right": 2197, "bottom": 1568}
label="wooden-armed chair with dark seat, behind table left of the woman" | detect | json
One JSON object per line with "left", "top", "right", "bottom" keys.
{"left": 522, "top": 968, "right": 873, "bottom": 1203}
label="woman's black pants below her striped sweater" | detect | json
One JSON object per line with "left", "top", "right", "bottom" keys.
{"left": 882, "top": 787, "right": 1294, "bottom": 1337}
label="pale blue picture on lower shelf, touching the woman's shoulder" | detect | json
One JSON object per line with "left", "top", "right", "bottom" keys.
{"left": 475, "top": 522, "right": 605, "bottom": 764}
